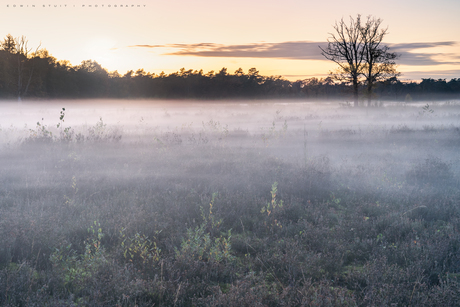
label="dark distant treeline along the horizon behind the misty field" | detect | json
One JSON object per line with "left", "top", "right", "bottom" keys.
{"left": 0, "top": 35, "right": 460, "bottom": 101}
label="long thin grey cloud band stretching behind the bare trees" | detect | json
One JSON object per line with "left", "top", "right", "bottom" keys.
{"left": 129, "top": 41, "right": 460, "bottom": 66}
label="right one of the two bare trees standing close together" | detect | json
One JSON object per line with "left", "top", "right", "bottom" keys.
{"left": 361, "top": 16, "right": 400, "bottom": 106}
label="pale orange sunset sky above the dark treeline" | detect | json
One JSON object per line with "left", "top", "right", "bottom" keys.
{"left": 0, "top": 0, "right": 460, "bottom": 81}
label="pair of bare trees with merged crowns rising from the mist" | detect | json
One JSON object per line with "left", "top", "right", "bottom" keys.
{"left": 320, "top": 14, "right": 399, "bottom": 106}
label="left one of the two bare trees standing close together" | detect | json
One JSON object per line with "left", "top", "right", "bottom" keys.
{"left": 320, "top": 15, "right": 365, "bottom": 107}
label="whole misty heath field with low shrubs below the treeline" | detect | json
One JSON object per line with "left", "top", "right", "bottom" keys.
{"left": 0, "top": 100, "right": 460, "bottom": 306}
